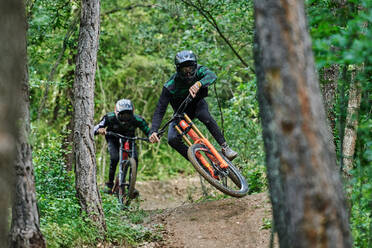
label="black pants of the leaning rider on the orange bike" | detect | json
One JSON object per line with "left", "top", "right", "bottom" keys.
{"left": 168, "top": 99, "right": 225, "bottom": 160}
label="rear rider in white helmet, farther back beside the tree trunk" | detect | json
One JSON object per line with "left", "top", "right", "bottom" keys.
{"left": 94, "top": 99, "right": 150, "bottom": 193}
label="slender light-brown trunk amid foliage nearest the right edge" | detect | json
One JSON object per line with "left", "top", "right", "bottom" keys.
{"left": 342, "top": 68, "right": 362, "bottom": 177}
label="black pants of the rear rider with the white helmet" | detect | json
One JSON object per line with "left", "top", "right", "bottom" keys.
{"left": 106, "top": 137, "right": 138, "bottom": 185}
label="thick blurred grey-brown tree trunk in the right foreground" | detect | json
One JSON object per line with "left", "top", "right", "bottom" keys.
{"left": 254, "top": 0, "right": 351, "bottom": 247}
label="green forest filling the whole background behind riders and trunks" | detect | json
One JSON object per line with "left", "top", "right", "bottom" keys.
{"left": 22, "top": 0, "right": 372, "bottom": 247}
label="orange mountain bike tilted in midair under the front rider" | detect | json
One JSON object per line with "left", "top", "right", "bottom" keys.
{"left": 158, "top": 95, "right": 248, "bottom": 197}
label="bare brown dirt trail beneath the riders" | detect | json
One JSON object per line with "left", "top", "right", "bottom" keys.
{"left": 136, "top": 177, "right": 278, "bottom": 248}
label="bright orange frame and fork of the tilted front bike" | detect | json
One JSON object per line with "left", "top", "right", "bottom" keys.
{"left": 175, "top": 114, "right": 229, "bottom": 178}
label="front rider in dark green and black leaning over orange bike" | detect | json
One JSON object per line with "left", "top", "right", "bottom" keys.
{"left": 150, "top": 50, "right": 238, "bottom": 160}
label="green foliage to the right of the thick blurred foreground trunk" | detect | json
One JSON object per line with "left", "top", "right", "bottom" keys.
{"left": 307, "top": 0, "right": 372, "bottom": 247}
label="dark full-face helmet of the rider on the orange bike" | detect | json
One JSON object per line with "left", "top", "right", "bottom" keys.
{"left": 174, "top": 50, "right": 197, "bottom": 81}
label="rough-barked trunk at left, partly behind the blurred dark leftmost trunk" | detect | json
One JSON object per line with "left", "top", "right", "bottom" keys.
{"left": 6, "top": 2, "right": 46, "bottom": 247}
